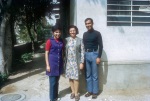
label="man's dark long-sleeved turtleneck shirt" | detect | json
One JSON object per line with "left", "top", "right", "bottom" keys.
{"left": 83, "top": 29, "right": 103, "bottom": 58}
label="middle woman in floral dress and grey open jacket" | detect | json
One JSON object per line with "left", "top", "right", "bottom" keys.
{"left": 65, "top": 25, "right": 84, "bottom": 101}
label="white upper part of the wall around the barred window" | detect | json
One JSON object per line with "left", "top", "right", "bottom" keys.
{"left": 74, "top": 0, "right": 150, "bottom": 63}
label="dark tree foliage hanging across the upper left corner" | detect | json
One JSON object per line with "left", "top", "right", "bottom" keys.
{"left": 0, "top": 0, "right": 53, "bottom": 42}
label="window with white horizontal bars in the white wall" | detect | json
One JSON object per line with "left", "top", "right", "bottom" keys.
{"left": 107, "top": 0, "right": 150, "bottom": 26}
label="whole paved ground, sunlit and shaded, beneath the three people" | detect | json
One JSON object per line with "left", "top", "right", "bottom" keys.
{"left": 0, "top": 54, "right": 150, "bottom": 101}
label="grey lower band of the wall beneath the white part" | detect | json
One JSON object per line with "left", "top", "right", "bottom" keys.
{"left": 80, "top": 62, "right": 150, "bottom": 92}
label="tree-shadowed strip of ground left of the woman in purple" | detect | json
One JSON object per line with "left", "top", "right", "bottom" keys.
{"left": 2, "top": 50, "right": 45, "bottom": 87}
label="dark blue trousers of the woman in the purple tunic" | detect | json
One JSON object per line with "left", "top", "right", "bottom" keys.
{"left": 49, "top": 76, "right": 60, "bottom": 101}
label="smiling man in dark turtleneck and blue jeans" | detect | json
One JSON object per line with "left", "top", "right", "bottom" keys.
{"left": 83, "top": 18, "right": 103, "bottom": 99}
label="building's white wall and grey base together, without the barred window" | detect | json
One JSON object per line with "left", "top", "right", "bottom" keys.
{"left": 71, "top": 0, "right": 150, "bottom": 89}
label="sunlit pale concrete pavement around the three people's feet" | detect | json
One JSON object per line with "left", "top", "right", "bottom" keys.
{"left": 0, "top": 72, "right": 150, "bottom": 101}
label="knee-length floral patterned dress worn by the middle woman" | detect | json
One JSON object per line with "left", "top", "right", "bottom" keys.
{"left": 66, "top": 37, "right": 84, "bottom": 80}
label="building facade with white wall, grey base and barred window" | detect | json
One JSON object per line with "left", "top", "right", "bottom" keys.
{"left": 70, "top": 0, "right": 150, "bottom": 89}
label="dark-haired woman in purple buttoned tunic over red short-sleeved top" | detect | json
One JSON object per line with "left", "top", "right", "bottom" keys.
{"left": 45, "top": 26, "right": 63, "bottom": 101}
